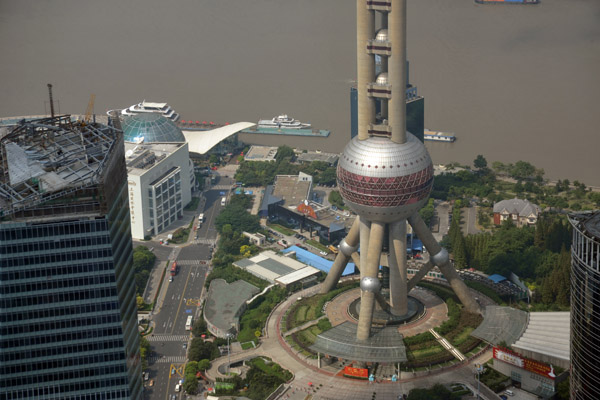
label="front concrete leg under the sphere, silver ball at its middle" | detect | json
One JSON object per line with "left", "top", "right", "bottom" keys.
{"left": 356, "top": 222, "right": 385, "bottom": 340}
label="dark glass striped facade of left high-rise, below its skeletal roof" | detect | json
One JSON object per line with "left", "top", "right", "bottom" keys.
{"left": 0, "top": 120, "right": 142, "bottom": 400}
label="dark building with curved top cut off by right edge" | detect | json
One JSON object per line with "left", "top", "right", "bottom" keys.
{"left": 569, "top": 211, "right": 600, "bottom": 400}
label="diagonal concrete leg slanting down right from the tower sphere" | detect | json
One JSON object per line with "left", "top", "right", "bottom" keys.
{"left": 408, "top": 212, "right": 481, "bottom": 314}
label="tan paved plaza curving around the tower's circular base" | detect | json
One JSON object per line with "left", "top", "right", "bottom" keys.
{"left": 207, "top": 286, "right": 499, "bottom": 400}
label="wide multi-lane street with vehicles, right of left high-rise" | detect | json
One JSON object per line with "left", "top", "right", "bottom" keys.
{"left": 142, "top": 171, "right": 233, "bottom": 400}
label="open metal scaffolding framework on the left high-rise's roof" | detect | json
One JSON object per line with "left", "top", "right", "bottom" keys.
{"left": 0, "top": 115, "right": 118, "bottom": 217}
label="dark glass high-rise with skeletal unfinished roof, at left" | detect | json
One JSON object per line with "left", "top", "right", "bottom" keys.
{"left": 0, "top": 116, "right": 142, "bottom": 400}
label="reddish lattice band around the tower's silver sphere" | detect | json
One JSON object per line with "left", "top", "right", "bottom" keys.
{"left": 337, "top": 165, "right": 433, "bottom": 207}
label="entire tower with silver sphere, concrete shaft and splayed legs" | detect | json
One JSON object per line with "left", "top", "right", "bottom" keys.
{"left": 321, "top": 0, "right": 480, "bottom": 342}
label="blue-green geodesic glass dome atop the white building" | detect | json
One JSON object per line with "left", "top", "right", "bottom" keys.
{"left": 121, "top": 113, "right": 185, "bottom": 143}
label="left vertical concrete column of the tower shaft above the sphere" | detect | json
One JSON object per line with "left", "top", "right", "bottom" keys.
{"left": 356, "top": 0, "right": 375, "bottom": 140}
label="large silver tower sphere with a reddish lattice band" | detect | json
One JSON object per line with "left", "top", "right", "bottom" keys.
{"left": 337, "top": 132, "right": 433, "bottom": 222}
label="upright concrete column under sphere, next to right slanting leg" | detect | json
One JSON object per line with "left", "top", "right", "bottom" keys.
{"left": 388, "top": 220, "right": 408, "bottom": 315}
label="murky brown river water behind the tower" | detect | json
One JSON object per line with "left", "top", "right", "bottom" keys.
{"left": 0, "top": 0, "right": 600, "bottom": 186}
